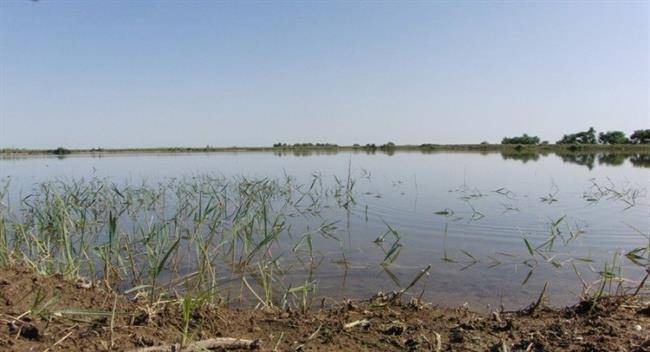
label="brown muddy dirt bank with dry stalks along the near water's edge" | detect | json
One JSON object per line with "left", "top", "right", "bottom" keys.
{"left": 0, "top": 268, "right": 650, "bottom": 351}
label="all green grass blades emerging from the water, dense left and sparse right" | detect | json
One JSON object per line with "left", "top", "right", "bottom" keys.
{"left": 0, "top": 172, "right": 650, "bottom": 312}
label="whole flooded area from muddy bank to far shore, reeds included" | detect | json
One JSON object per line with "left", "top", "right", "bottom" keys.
{"left": 0, "top": 152, "right": 650, "bottom": 309}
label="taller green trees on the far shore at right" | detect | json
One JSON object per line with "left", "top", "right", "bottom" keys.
{"left": 501, "top": 127, "right": 650, "bottom": 145}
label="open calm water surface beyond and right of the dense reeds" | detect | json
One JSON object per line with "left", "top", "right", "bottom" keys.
{"left": 0, "top": 152, "right": 650, "bottom": 309}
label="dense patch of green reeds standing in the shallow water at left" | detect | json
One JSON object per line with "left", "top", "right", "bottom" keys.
{"left": 0, "top": 175, "right": 354, "bottom": 309}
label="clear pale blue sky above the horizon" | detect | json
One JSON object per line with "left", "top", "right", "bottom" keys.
{"left": 0, "top": 0, "right": 650, "bottom": 148}
